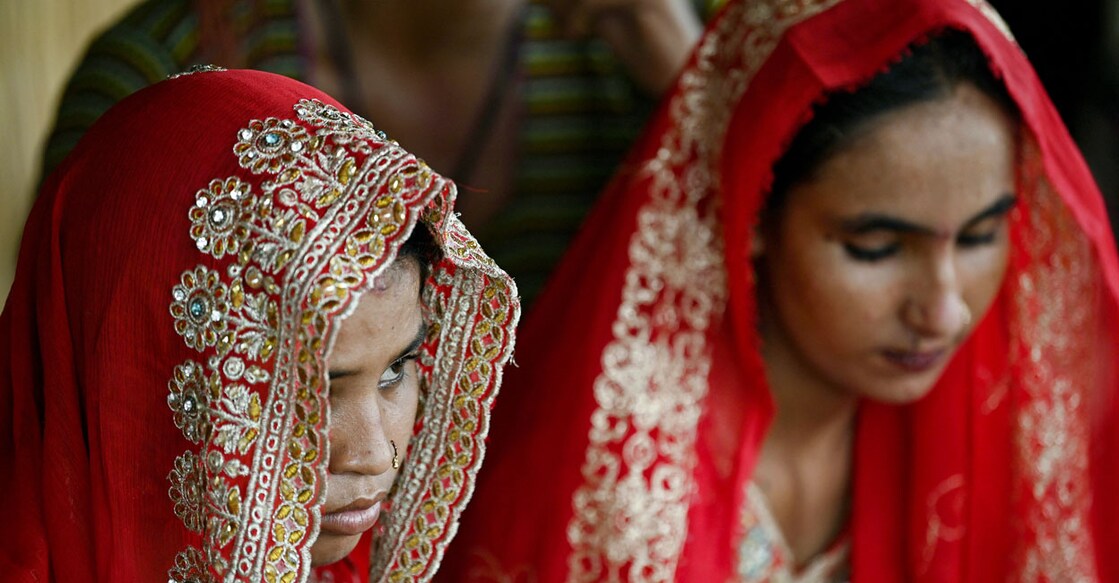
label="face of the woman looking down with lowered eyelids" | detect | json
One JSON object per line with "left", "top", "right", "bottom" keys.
{"left": 759, "top": 84, "right": 1016, "bottom": 403}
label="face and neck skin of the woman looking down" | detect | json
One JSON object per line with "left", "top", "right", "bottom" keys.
{"left": 753, "top": 84, "right": 1017, "bottom": 561}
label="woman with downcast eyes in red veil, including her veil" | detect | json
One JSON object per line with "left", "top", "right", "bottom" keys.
{"left": 442, "top": 0, "right": 1119, "bottom": 583}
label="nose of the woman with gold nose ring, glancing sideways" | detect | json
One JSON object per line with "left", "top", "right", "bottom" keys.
{"left": 330, "top": 402, "right": 396, "bottom": 476}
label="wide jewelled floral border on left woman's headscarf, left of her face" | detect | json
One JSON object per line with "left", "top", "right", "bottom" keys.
{"left": 168, "top": 101, "right": 442, "bottom": 582}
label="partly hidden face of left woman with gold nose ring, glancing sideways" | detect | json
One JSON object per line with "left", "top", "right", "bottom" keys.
{"left": 311, "top": 260, "right": 426, "bottom": 565}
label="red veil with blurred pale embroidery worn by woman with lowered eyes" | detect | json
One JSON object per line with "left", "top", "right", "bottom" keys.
{"left": 443, "top": 0, "right": 1119, "bottom": 583}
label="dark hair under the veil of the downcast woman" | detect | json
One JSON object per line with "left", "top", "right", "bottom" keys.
{"left": 765, "top": 30, "right": 1017, "bottom": 215}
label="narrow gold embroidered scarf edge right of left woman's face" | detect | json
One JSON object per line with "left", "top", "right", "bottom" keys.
{"left": 373, "top": 250, "right": 518, "bottom": 583}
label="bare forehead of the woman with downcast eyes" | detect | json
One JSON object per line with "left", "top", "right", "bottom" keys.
{"left": 789, "top": 84, "right": 1016, "bottom": 222}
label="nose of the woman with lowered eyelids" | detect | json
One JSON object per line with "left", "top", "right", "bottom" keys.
{"left": 902, "top": 253, "right": 971, "bottom": 337}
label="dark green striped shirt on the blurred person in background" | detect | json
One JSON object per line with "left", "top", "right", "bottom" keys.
{"left": 43, "top": 0, "right": 709, "bottom": 304}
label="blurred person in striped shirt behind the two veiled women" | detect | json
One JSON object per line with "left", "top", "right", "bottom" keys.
{"left": 34, "top": 0, "right": 720, "bottom": 301}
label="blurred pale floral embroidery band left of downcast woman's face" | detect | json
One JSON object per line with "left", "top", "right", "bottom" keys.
{"left": 567, "top": 0, "right": 838, "bottom": 582}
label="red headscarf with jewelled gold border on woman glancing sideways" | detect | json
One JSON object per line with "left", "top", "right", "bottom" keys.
{"left": 0, "top": 66, "right": 519, "bottom": 583}
